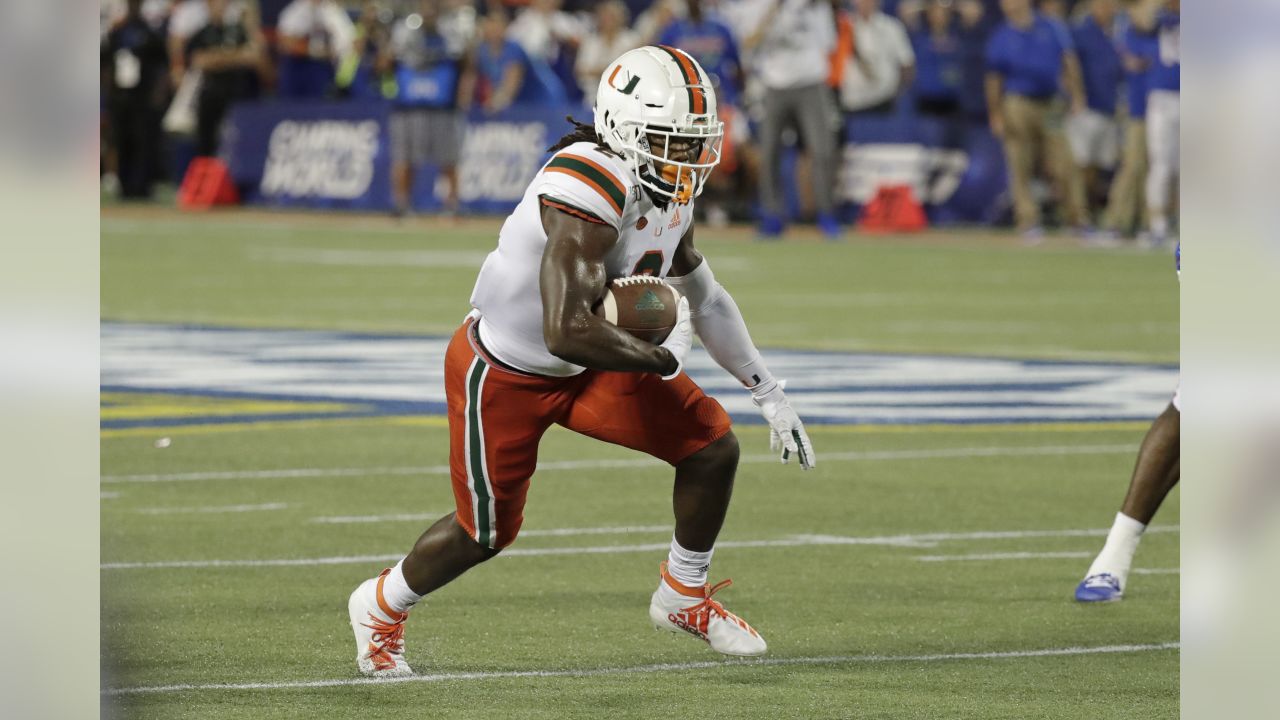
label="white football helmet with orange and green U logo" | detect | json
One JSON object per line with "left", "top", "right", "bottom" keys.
{"left": 595, "top": 45, "right": 724, "bottom": 202}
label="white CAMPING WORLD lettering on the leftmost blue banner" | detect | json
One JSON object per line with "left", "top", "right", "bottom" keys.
{"left": 261, "top": 120, "right": 378, "bottom": 200}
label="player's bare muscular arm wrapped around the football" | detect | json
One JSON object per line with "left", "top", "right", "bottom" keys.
{"left": 539, "top": 206, "right": 680, "bottom": 375}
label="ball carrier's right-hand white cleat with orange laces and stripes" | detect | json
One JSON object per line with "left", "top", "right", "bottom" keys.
{"left": 649, "top": 562, "right": 768, "bottom": 656}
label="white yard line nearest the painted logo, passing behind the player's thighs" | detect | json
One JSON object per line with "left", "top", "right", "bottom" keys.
{"left": 102, "top": 445, "right": 1138, "bottom": 483}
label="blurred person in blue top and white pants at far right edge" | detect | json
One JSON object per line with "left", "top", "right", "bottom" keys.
{"left": 1147, "top": 0, "right": 1181, "bottom": 246}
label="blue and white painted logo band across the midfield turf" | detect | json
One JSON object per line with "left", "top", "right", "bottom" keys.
{"left": 101, "top": 323, "right": 1178, "bottom": 428}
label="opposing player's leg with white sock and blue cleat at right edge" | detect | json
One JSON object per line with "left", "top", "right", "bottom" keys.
{"left": 1075, "top": 397, "right": 1181, "bottom": 602}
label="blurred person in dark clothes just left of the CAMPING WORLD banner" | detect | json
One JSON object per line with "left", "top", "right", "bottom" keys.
{"left": 187, "top": 0, "right": 264, "bottom": 155}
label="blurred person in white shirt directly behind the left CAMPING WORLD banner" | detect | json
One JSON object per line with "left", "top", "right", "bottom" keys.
{"left": 275, "top": 0, "right": 356, "bottom": 97}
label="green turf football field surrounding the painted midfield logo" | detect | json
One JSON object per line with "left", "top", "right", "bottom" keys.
{"left": 101, "top": 208, "right": 1179, "bottom": 720}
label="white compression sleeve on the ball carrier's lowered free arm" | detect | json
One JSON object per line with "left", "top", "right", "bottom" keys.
{"left": 667, "top": 258, "right": 777, "bottom": 396}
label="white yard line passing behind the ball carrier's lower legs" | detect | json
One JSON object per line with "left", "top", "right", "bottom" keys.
{"left": 100, "top": 525, "right": 1179, "bottom": 570}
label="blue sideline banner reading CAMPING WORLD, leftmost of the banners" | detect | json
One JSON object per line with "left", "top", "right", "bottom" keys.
{"left": 219, "top": 101, "right": 392, "bottom": 210}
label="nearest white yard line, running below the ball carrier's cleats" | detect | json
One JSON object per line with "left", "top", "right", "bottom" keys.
{"left": 102, "top": 642, "right": 1180, "bottom": 696}
